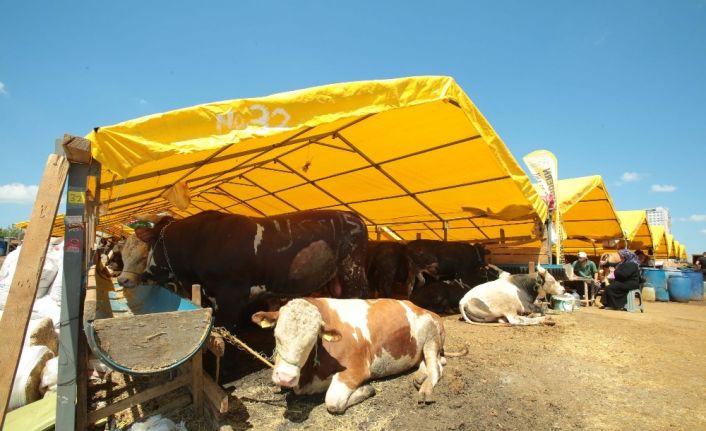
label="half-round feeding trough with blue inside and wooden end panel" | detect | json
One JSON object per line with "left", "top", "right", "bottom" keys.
{"left": 83, "top": 276, "right": 213, "bottom": 375}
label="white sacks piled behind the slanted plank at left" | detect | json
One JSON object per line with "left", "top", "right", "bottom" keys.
{"left": 0, "top": 238, "right": 64, "bottom": 410}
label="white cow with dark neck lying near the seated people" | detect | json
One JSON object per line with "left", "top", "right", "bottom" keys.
{"left": 459, "top": 265, "right": 564, "bottom": 325}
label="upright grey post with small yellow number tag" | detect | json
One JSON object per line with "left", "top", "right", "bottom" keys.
{"left": 56, "top": 163, "right": 90, "bottom": 430}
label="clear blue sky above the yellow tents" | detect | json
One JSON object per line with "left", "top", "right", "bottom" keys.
{"left": 0, "top": 0, "right": 706, "bottom": 253}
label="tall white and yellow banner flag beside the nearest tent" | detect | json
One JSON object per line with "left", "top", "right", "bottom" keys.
{"left": 522, "top": 150, "right": 564, "bottom": 264}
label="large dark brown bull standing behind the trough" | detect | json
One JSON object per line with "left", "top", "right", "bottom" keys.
{"left": 118, "top": 211, "right": 368, "bottom": 328}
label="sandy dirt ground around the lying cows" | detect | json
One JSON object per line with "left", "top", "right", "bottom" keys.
{"left": 96, "top": 302, "right": 706, "bottom": 430}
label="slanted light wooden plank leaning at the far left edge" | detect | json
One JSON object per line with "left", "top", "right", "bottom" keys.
{"left": 0, "top": 154, "right": 69, "bottom": 429}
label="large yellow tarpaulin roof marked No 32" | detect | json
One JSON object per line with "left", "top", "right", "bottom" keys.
{"left": 87, "top": 77, "right": 547, "bottom": 241}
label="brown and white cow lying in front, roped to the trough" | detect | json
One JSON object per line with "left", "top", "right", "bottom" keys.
{"left": 252, "top": 298, "right": 445, "bottom": 413}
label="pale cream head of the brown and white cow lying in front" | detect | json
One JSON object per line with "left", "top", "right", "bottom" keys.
{"left": 252, "top": 299, "right": 341, "bottom": 388}
